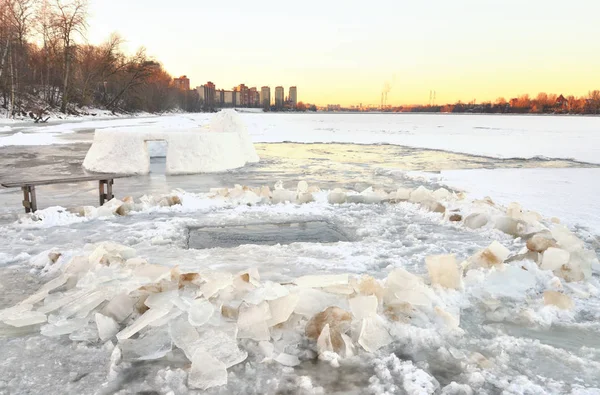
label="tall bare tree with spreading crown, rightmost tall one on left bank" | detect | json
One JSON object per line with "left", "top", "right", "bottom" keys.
{"left": 52, "top": 0, "right": 88, "bottom": 113}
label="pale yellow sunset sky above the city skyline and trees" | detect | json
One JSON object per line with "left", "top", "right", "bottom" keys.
{"left": 88, "top": 0, "right": 600, "bottom": 105}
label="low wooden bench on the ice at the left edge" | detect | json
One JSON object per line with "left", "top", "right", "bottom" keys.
{"left": 0, "top": 174, "right": 130, "bottom": 213}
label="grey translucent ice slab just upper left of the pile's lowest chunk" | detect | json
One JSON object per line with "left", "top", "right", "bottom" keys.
{"left": 119, "top": 328, "right": 173, "bottom": 361}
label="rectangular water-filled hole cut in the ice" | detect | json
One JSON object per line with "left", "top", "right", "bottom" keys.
{"left": 188, "top": 221, "right": 350, "bottom": 250}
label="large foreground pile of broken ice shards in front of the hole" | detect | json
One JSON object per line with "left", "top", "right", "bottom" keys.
{"left": 0, "top": 224, "right": 590, "bottom": 390}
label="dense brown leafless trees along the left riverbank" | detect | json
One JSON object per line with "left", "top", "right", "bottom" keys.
{"left": 0, "top": 0, "right": 198, "bottom": 121}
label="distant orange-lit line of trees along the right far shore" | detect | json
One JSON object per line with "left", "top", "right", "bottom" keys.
{"left": 392, "top": 90, "right": 600, "bottom": 114}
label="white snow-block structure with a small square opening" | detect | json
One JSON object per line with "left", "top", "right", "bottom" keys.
{"left": 83, "top": 110, "right": 259, "bottom": 174}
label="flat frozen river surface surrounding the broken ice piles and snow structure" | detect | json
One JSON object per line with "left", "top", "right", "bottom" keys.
{"left": 0, "top": 114, "right": 600, "bottom": 394}
